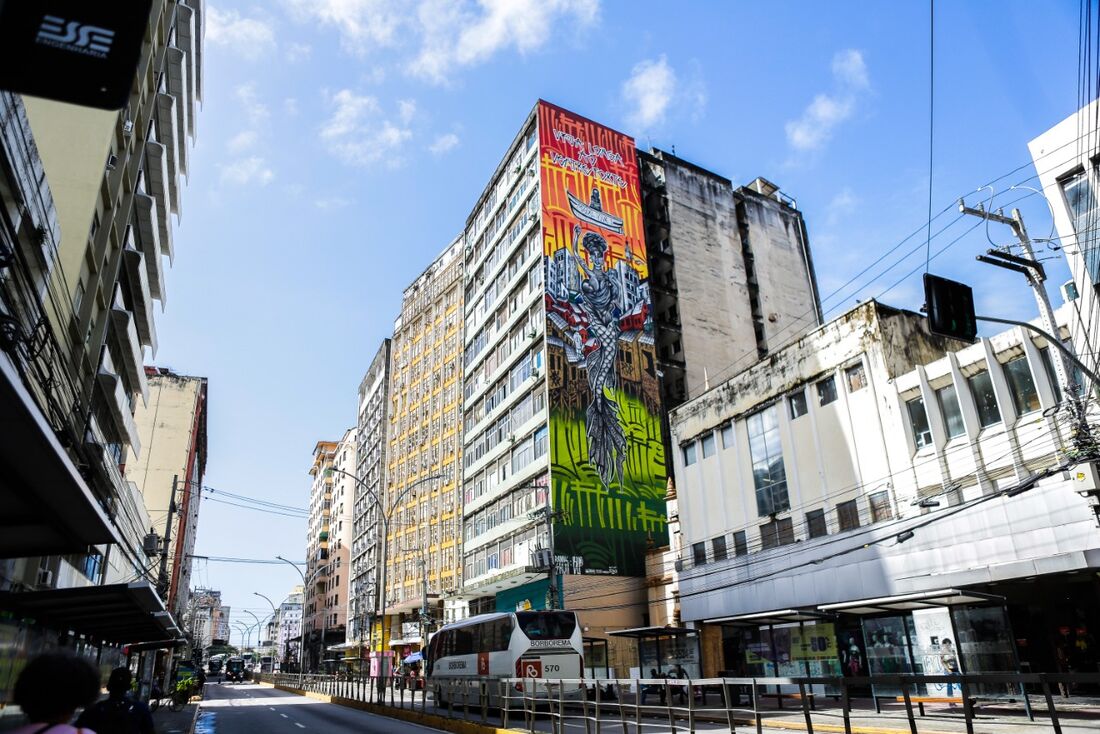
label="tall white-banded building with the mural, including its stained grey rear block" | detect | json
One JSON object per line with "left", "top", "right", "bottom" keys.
{"left": 451, "top": 101, "right": 821, "bottom": 673}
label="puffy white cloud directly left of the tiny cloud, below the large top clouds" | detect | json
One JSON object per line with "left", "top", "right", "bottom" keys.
{"left": 320, "top": 89, "right": 413, "bottom": 166}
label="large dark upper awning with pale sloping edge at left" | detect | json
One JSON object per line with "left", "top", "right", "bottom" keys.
{"left": 0, "top": 358, "right": 121, "bottom": 556}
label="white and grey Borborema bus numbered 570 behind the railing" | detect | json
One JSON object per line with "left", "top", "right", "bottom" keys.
{"left": 425, "top": 610, "right": 584, "bottom": 705}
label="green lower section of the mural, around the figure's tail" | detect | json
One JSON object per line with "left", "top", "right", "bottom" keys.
{"left": 550, "top": 390, "right": 668, "bottom": 576}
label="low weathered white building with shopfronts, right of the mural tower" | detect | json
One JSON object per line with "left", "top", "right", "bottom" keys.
{"left": 671, "top": 302, "right": 1100, "bottom": 677}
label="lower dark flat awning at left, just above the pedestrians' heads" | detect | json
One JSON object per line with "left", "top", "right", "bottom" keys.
{"left": 0, "top": 582, "right": 183, "bottom": 644}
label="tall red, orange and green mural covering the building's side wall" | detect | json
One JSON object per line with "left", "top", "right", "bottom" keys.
{"left": 538, "top": 102, "right": 668, "bottom": 576}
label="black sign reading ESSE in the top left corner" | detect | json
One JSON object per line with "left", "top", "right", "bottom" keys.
{"left": 0, "top": 0, "right": 153, "bottom": 110}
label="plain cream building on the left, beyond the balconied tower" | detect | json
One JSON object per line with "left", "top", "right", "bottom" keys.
{"left": 125, "top": 368, "right": 207, "bottom": 615}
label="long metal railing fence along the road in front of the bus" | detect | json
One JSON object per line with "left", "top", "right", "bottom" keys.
{"left": 261, "top": 673, "right": 1100, "bottom": 734}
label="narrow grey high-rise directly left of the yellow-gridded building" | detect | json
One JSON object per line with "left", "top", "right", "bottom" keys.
{"left": 348, "top": 339, "right": 391, "bottom": 651}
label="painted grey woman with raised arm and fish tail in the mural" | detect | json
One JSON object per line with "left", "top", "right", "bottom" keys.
{"left": 572, "top": 221, "right": 626, "bottom": 487}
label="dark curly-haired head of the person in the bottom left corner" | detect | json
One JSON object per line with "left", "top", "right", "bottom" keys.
{"left": 9, "top": 653, "right": 99, "bottom": 734}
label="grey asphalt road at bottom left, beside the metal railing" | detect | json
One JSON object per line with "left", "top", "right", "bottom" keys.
{"left": 195, "top": 683, "right": 451, "bottom": 734}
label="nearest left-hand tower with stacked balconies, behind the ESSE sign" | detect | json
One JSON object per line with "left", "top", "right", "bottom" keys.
{"left": 0, "top": 0, "right": 204, "bottom": 664}
